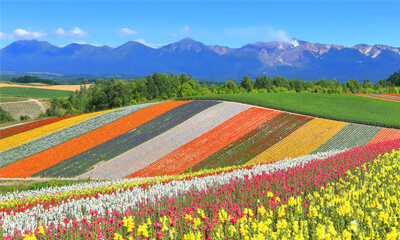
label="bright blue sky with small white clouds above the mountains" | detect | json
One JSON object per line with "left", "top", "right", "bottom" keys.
{"left": 0, "top": 0, "right": 400, "bottom": 48}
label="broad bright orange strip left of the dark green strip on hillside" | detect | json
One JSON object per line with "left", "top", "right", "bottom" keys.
{"left": 0, "top": 101, "right": 189, "bottom": 177}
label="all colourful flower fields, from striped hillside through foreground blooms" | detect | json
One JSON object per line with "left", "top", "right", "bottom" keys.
{"left": 0, "top": 100, "right": 400, "bottom": 239}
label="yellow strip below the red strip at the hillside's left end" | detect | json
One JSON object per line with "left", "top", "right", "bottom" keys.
{"left": 0, "top": 110, "right": 112, "bottom": 151}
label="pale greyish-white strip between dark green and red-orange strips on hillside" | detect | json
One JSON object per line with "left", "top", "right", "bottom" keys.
{"left": 80, "top": 102, "right": 249, "bottom": 178}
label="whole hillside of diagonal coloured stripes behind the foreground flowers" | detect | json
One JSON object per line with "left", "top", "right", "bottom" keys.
{"left": 0, "top": 101, "right": 400, "bottom": 178}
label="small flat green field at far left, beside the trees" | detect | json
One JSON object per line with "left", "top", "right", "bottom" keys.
{"left": 0, "top": 87, "right": 71, "bottom": 98}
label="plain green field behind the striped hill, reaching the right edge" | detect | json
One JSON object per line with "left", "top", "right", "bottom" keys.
{"left": 186, "top": 93, "right": 400, "bottom": 129}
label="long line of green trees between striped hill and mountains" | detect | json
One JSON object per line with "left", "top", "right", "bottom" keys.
{"left": 39, "top": 69, "right": 400, "bottom": 116}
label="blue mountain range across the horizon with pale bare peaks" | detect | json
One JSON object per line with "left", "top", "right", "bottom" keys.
{"left": 0, "top": 38, "right": 400, "bottom": 82}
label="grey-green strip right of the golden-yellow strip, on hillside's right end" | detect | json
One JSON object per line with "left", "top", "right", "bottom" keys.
{"left": 312, "top": 123, "right": 382, "bottom": 153}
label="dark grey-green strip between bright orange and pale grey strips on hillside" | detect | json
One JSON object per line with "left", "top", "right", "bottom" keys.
{"left": 33, "top": 101, "right": 222, "bottom": 177}
